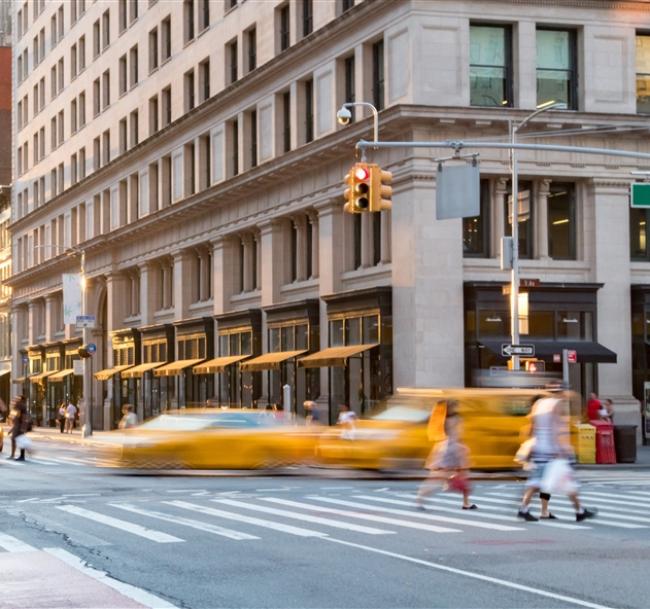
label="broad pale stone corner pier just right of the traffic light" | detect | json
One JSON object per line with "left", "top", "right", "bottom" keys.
{"left": 391, "top": 173, "right": 465, "bottom": 387}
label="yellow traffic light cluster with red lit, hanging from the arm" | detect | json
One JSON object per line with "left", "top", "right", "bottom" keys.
{"left": 343, "top": 163, "right": 393, "bottom": 214}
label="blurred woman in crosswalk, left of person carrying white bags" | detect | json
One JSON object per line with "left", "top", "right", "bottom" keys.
{"left": 415, "top": 400, "right": 478, "bottom": 511}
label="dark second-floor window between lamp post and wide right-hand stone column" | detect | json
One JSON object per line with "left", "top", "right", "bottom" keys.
{"left": 548, "top": 183, "right": 576, "bottom": 260}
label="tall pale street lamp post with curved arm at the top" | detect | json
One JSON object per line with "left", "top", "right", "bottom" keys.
{"left": 510, "top": 101, "right": 566, "bottom": 370}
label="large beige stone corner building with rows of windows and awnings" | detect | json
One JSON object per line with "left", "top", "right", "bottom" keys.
{"left": 11, "top": 0, "right": 650, "bottom": 436}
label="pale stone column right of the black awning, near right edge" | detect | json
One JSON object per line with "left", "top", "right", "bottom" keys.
{"left": 584, "top": 179, "right": 640, "bottom": 429}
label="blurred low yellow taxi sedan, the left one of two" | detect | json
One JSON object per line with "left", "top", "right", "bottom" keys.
{"left": 103, "top": 409, "right": 317, "bottom": 469}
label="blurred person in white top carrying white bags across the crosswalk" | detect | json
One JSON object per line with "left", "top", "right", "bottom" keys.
{"left": 517, "top": 387, "right": 596, "bottom": 522}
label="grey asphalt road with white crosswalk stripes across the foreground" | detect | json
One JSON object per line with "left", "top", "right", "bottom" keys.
{"left": 0, "top": 443, "right": 650, "bottom": 609}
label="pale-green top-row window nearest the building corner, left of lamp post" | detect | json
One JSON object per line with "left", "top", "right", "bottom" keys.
{"left": 469, "top": 25, "right": 512, "bottom": 107}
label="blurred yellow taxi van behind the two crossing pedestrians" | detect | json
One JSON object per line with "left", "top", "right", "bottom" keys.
{"left": 316, "top": 388, "right": 576, "bottom": 469}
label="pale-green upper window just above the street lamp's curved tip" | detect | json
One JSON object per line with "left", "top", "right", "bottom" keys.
{"left": 537, "top": 29, "right": 577, "bottom": 110}
